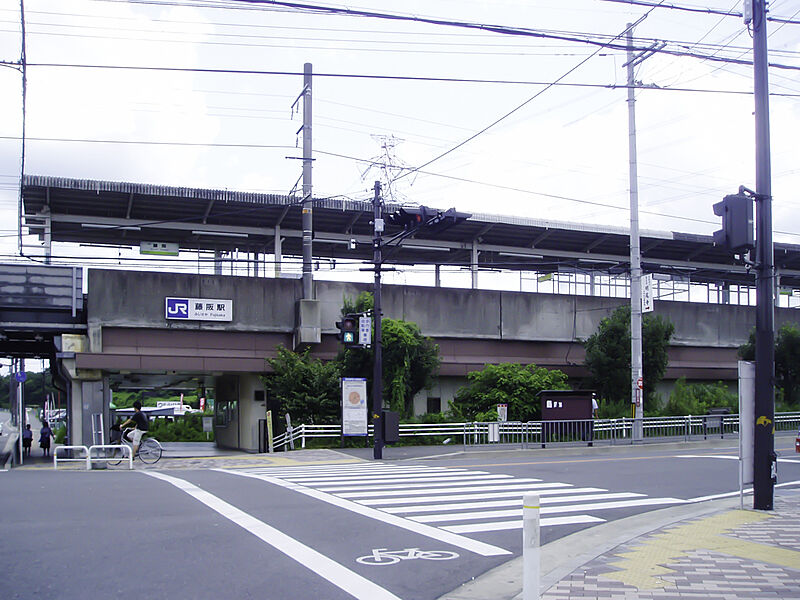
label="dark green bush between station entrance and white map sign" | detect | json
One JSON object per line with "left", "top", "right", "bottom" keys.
{"left": 264, "top": 346, "right": 341, "bottom": 424}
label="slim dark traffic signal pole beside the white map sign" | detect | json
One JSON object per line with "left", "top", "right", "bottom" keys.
{"left": 372, "top": 181, "right": 384, "bottom": 460}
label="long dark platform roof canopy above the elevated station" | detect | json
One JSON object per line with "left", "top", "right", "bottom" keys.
{"left": 22, "top": 175, "right": 800, "bottom": 288}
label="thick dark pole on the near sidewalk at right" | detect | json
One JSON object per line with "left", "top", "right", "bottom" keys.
{"left": 745, "top": 0, "right": 776, "bottom": 510}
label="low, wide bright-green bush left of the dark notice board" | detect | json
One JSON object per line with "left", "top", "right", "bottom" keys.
{"left": 450, "top": 363, "right": 569, "bottom": 421}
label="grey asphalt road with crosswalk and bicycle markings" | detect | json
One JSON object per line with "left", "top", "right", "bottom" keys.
{"left": 0, "top": 438, "right": 800, "bottom": 600}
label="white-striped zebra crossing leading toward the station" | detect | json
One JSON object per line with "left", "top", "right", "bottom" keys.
{"left": 225, "top": 464, "right": 686, "bottom": 534}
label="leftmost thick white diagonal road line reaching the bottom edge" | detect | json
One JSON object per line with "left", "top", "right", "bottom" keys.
{"left": 140, "top": 471, "right": 400, "bottom": 600}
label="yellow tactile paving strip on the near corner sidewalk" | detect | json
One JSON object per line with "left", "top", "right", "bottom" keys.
{"left": 602, "top": 510, "right": 800, "bottom": 590}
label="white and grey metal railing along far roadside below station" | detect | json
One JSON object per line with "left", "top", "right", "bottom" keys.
{"left": 274, "top": 412, "right": 800, "bottom": 450}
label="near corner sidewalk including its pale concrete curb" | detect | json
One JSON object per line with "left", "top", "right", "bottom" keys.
{"left": 440, "top": 489, "right": 800, "bottom": 600}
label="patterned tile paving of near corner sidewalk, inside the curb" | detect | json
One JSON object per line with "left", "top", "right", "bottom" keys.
{"left": 542, "top": 496, "right": 800, "bottom": 600}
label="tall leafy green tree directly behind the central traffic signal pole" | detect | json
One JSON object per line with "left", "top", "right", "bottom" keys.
{"left": 339, "top": 292, "right": 440, "bottom": 419}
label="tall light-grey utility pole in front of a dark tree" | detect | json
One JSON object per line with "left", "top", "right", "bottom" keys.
{"left": 626, "top": 23, "right": 644, "bottom": 442}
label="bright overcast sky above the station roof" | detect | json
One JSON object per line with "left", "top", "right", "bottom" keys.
{"left": 0, "top": 0, "right": 800, "bottom": 268}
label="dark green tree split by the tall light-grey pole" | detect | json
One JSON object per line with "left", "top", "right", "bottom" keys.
{"left": 583, "top": 306, "right": 675, "bottom": 412}
